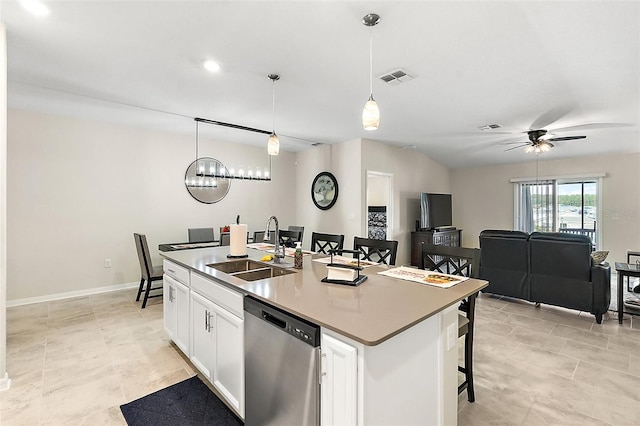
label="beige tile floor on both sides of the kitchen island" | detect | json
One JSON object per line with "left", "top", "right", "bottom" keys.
{"left": 0, "top": 290, "right": 640, "bottom": 426}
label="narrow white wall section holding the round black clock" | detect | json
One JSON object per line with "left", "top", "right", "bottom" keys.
{"left": 296, "top": 139, "right": 363, "bottom": 249}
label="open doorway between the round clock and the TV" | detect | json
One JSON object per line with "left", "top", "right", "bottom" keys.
{"left": 365, "top": 170, "right": 393, "bottom": 240}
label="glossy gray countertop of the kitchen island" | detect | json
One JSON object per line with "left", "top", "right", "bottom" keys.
{"left": 160, "top": 247, "right": 488, "bottom": 346}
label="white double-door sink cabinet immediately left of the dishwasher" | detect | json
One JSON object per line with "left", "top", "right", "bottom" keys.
{"left": 191, "top": 274, "right": 244, "bottom": 418}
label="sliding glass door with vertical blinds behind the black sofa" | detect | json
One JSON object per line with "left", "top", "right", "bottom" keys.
{"left": 512, "top": 176, "right": 602, "bottom": 248}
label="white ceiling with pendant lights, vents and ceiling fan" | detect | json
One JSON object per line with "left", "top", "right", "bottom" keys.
{"left": 0, "top": 0, "right": 640, "bottom": 168}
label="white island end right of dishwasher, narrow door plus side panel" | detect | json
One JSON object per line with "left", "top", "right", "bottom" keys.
{"left": 321, "top": 305, "right": 458, "bottom": 426}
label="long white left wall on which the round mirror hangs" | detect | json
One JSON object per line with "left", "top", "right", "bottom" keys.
{"left": 7, "top": 110, "right": 297, "bottom": 301}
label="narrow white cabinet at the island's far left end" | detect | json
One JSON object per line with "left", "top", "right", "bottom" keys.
{"left": 162, "top": 275, "right": 190, "bottom": 356}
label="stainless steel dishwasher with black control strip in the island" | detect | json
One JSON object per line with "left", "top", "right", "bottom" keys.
{"left": 244, "top": 296, "right": 320, "bottom": 426}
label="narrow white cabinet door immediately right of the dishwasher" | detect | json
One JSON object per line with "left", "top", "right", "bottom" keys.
{"left": 320, "top": 332, "right": 358, "bottom": 426}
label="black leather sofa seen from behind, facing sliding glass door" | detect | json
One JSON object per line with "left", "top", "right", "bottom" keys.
{"left": 480, "top": 230, "right": 611, "bottom": 324}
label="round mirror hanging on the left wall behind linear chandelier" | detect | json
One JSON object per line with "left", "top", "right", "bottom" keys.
{"left": 184, "top": 157, "right": 231, "bottom": 204}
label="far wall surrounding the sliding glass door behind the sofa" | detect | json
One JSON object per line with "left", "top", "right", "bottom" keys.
{"left": 451, "top": 151, "right": 640, "bottom": 265}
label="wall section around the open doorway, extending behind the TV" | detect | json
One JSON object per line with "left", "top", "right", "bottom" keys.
{"left": 361, "top": 140, "right": 450, "bottom": 265}
